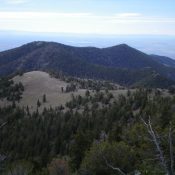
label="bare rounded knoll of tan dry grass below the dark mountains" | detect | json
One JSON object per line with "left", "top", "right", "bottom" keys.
{"left": 10, "top": 71, "right": 86, "bottom": 111}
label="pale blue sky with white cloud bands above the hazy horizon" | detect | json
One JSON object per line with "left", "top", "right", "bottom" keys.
{"left": 0, "top": 0, "right": 175, "bottom": 35}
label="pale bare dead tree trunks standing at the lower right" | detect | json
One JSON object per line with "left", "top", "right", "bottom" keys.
{"left": 141, "top": 116, "right": 174, "bottom": 175}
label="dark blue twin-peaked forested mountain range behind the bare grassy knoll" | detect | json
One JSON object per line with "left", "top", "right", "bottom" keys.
{"left": 0, "top": 41, "right": 175, "bottom": 88}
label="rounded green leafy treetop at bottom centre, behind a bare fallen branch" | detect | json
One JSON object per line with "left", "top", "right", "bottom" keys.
{"left": 80, "top": 142, "right": 137, "bottom": 175}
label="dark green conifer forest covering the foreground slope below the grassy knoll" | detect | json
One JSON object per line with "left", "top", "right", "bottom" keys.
{"left": 0, "top": 89, "right": 175, "bottom": 175}
